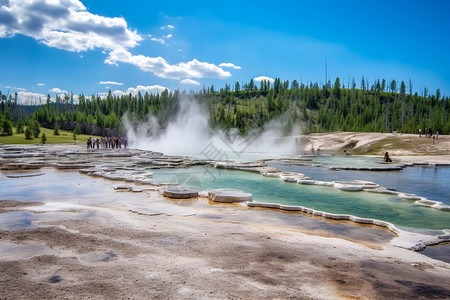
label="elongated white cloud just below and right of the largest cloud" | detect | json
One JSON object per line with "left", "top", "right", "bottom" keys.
{"left": 105, "top": 49, "right": 231, "bottom": 80}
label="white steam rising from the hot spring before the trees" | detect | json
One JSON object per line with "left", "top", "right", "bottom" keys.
{"left": 123, "top": 98, "right": 300, "bottom": 160}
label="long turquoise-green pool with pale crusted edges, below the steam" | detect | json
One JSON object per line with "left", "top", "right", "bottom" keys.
{"left": 151, "top": 167, "right": 450, "bottom": 230}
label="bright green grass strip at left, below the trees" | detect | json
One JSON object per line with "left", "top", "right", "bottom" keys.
{"left": 0, "top": 127, "right": 97, "bottom": 144}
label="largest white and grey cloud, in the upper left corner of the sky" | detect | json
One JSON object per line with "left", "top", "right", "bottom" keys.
{"left": 0, "top": 0, "right": 142, "bottom": 52}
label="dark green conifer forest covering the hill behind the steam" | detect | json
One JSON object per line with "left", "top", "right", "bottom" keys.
{"left": 0, "top": 77, "right": 450, "bottom": 139}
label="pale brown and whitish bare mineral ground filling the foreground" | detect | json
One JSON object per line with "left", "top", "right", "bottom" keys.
{"left": 0, "top": 136, "right": 450, "bottom": 299}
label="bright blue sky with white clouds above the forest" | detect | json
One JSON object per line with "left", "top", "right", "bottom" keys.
{"left": 0, "top": 0, "right": 450, "bottom": 103}
